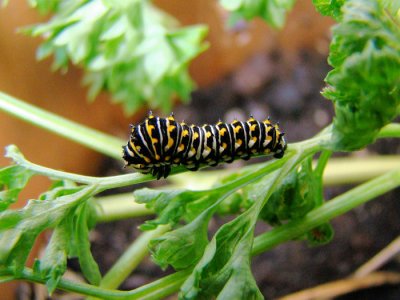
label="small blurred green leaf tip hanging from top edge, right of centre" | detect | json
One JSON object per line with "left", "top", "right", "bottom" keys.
{"left": 219, "top": 0, "right": 295, "bottom": 28}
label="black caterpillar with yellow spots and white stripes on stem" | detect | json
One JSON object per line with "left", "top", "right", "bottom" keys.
{"left": 123, "top": 112, "right": 286, "bottom": 179}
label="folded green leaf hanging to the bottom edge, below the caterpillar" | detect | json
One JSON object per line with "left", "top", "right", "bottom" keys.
{"left": 180, "top": 209, "right": 263, "bottom": 299}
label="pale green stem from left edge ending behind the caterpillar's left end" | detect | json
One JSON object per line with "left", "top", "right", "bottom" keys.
{"left": 0, "top": 92, "right": 125, "bottom": 159}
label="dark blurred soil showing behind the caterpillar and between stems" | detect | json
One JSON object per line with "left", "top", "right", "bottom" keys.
{"left": 92, "top": 51, "right": 400, "bottom": 299}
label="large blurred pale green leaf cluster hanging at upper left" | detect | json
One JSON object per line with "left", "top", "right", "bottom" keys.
{"left": 25, "top": 0, "right": 207, "bottom": 114}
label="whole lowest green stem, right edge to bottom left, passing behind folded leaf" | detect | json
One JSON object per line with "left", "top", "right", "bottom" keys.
{"left": 7, "top": 170, "right": 400, "bottom": 299}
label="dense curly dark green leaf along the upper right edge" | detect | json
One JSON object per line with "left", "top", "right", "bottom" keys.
{"left": 323, "top": 0, "right": 400, "bottom": 151}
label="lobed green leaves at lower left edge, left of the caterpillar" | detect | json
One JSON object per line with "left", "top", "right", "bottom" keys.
{"left": 0, "top": 146, "right": 100, "bottom": 293}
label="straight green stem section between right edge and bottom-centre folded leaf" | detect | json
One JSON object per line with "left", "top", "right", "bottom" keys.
{"left": 252, "top": 170, "right": 400, "bottom": 255}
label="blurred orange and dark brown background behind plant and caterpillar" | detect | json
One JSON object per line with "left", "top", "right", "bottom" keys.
{"left": 0, "top": 0, "right": 400, "bottom": 299}
